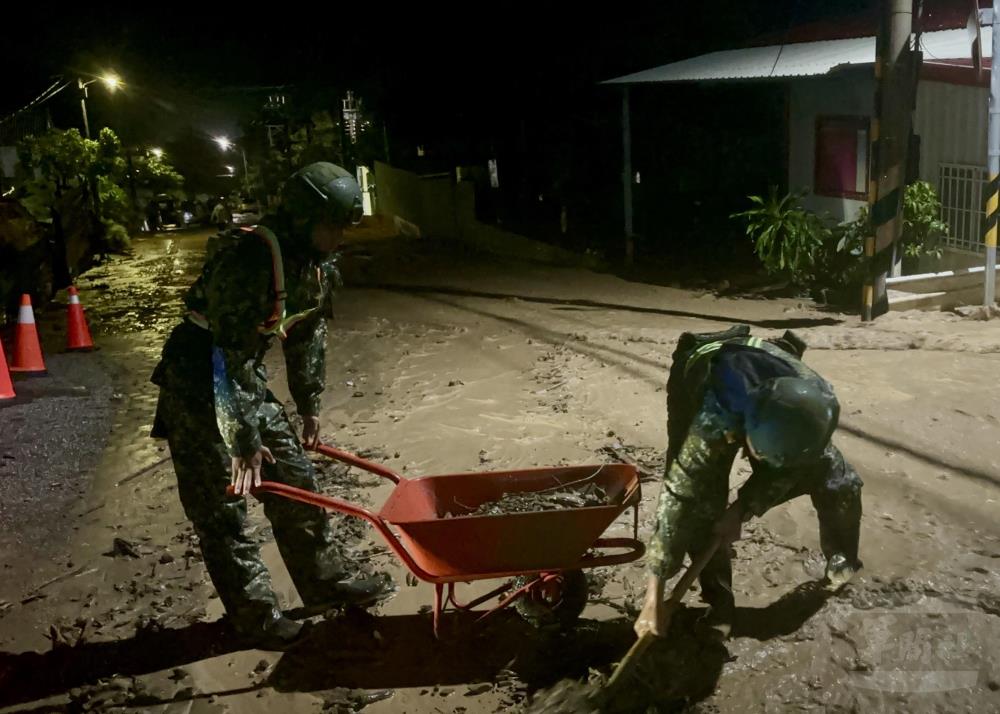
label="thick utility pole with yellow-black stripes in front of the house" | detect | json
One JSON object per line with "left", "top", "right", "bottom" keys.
{"left": 861, "top": 0, "right": 920, "bottom": 321}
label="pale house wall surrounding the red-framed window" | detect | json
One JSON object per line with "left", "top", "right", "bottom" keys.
{"left": 788, "top": 68, "right": 875, "bottom": 222}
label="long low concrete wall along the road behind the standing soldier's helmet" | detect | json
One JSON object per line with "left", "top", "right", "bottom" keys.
{"left": 375, "top": 162, "right": 600, "bottom": 268}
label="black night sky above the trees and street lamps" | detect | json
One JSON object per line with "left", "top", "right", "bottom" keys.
{"left": 0, "top": 0, "right": 871, "bottom": 142}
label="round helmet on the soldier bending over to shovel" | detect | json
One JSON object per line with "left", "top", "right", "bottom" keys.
{"left": 744, "top": 377, "right": 840, "bottom": 467}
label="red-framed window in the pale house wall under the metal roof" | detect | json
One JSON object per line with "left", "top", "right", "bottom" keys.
{"left": 813, "top": 116, "right": 868, "bottom": 199}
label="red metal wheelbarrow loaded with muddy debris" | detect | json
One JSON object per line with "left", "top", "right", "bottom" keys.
{"left": 246, "top": 445, "right": 645, "bottom": 636}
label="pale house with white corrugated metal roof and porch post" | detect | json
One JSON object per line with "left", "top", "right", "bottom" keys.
{"left": 604, "top": 0, "right": 992, "bottom": 266}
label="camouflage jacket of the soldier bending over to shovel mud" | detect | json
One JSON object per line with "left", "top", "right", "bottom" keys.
{"left": 664, "top": 337, "right": 833, "bottom": 516}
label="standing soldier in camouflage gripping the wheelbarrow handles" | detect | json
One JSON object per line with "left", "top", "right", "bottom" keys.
{"left": 152, "top": 163, "right": 382, "bottom": 648}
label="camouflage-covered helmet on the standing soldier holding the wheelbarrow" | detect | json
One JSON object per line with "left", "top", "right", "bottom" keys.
{"left": 281, "top": 161, "right": 363, "bottom": 226}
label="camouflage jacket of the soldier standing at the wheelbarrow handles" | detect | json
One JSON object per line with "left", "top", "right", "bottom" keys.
{"left": 184, "top": 219, "right": 340, "bottom": 456}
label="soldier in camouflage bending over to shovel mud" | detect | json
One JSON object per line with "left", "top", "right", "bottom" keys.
{"left": 635, "top": 325, "right": 862, "bottom": 636}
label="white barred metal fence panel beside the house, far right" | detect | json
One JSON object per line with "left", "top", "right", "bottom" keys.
{"left": 938, "top": 164, "right": 986, "bottom": 253}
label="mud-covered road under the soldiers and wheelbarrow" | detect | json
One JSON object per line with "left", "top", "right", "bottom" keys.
{"left": 0, "top": 229, "right": 1000, "bottom": 713}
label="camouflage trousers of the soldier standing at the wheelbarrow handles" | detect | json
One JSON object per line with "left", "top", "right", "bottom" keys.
{"left": 154, "top": 389, "right": 344, "bottom": 631}
